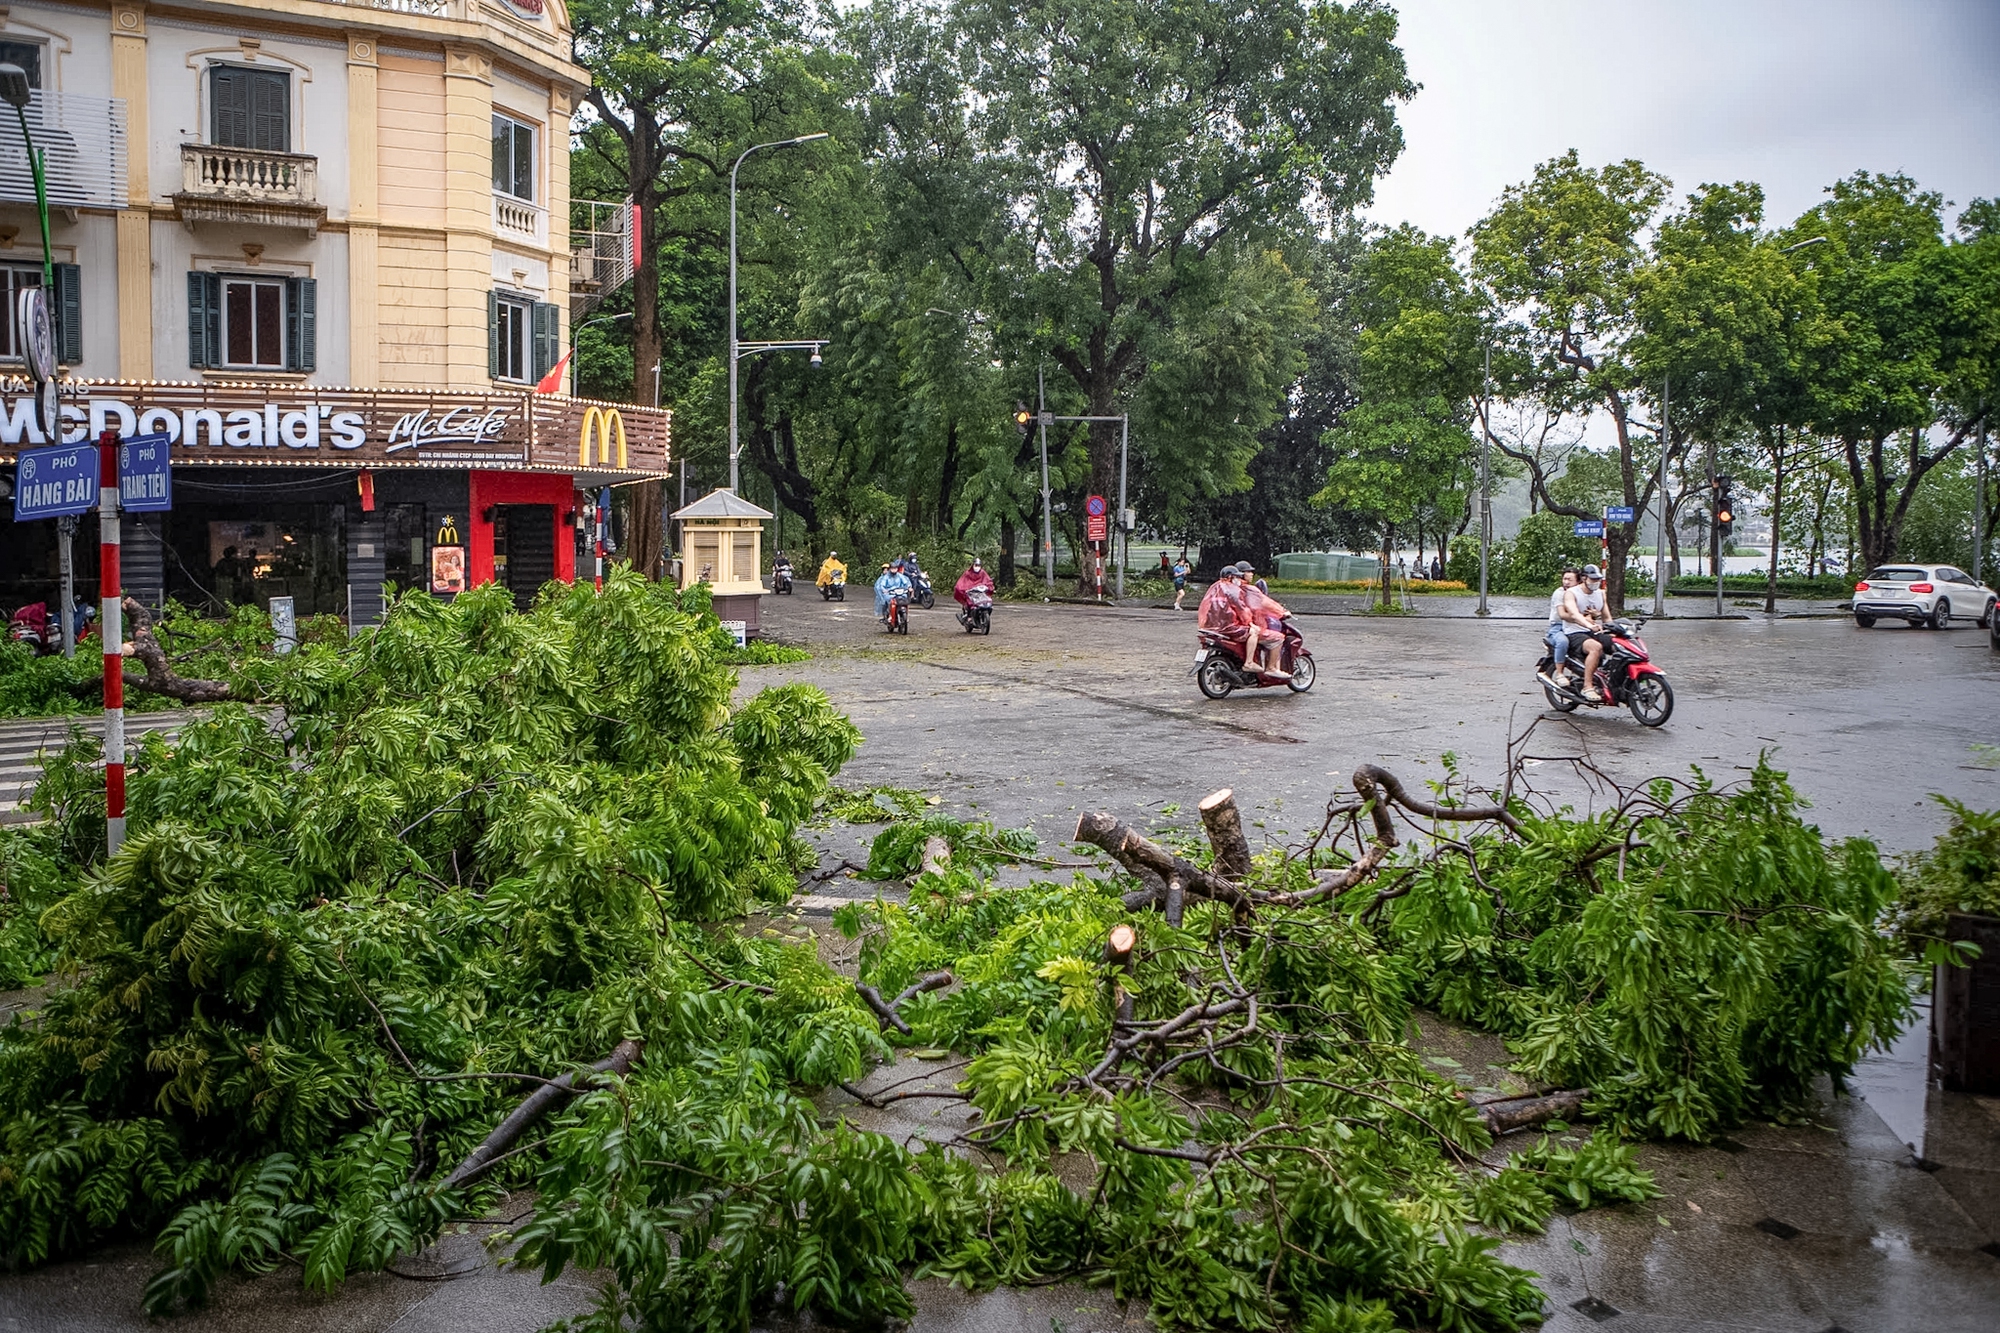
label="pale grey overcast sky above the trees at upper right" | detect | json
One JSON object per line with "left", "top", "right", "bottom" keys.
{"left": 1368, "top": 0, "right": 2000, "bottom": 234}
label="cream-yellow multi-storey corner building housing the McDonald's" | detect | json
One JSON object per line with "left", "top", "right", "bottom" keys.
{"left": 0, "top": 0, "right": 668, "bottom": 620}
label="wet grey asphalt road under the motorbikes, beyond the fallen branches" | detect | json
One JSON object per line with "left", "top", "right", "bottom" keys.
{"left": 744, "top": 588, "right": 2000, "bottom": 851}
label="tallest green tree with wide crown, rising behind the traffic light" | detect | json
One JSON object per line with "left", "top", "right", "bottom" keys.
{"left": 856, "top": 0, "right": 1414, "bottom": 580}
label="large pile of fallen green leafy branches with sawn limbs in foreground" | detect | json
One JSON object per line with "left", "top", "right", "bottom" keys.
{"left": 0, "top": 574, "right": 1936, "bottom": 1333}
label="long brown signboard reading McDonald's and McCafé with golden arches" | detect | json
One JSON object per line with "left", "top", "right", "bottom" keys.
{"left": 0, "top": 380, "right": 670, "bottom": 472}
